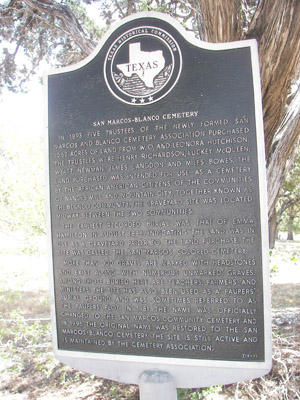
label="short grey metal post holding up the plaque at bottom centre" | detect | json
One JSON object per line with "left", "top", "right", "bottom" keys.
{"left": 140, "top": 370, "right": 177, "bottom": 400}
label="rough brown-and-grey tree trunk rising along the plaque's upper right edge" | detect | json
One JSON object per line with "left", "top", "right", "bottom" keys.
{"left": 247, "top": 0, "right": 300, "bottom": 223}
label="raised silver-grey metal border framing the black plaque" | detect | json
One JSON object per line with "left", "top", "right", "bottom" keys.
{"left": 44, "top": 11, "right": 272, "bottom": 388}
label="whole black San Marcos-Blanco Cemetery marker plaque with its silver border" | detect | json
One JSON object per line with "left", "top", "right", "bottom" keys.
{"left": 47, "top": 13, "right": 271, "bottom": 386}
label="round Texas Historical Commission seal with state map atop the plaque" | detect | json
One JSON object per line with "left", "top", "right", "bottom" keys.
{"left": 104, "top": 26, "right": 182, "bottom": 106}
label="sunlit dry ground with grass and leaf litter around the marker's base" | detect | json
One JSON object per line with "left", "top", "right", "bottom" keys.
{"left": 0, "top": 242, "right": 300, "bottom": 400}
